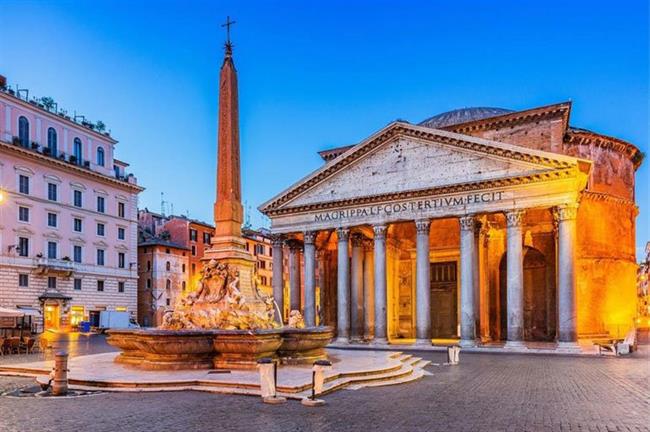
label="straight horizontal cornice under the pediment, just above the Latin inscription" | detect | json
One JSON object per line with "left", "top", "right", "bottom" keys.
{"left": 266, "top": 169, "right": 575, "bottom": 216}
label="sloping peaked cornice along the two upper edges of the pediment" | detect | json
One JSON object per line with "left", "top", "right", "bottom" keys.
{"left": 259, "top": 122, "right": 576, "bottom": 215}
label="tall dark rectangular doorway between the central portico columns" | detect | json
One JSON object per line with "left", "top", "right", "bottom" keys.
{"left": 430, "top": 261, "right": 458, "bottom": 338}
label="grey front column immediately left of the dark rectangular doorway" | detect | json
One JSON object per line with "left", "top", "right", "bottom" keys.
{"left": 415, "top": 219, "right": 431, "bottom": 345}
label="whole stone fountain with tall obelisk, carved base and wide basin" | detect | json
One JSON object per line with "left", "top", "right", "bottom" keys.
{"left": 107, "top": 33, "right": 334, "bottom": 370}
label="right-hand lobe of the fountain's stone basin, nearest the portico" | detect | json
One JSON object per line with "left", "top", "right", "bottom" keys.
{"left": 278, "top": 326, "right": 334, "bottom": 365}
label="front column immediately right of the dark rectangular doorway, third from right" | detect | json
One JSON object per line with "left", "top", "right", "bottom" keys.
{"left": 460, "top": 216, "right": 477, "bottom": 346}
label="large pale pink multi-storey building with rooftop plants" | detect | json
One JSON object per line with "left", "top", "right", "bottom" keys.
{"left": 0, "top": 77, "right": 142, "bottom": 330}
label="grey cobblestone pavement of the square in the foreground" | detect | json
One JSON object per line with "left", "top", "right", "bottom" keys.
{"left": 0, "top": 341, "right": 650, "bottom": 432}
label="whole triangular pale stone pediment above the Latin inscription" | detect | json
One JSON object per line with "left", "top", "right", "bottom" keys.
{"left": 260, "top": 122, "right": 589, "bottom": 213}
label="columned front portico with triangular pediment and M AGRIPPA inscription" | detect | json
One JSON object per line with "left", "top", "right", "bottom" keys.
{"left": 260, "top": 122, "right": 591, "bottom": 347}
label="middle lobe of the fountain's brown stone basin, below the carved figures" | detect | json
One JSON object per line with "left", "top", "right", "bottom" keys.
{"left": 213, "top": 329, "right": 282, "bottom": 369}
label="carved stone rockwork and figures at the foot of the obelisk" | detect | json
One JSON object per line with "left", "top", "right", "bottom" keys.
{"left": 161, "top": 260, "right": 278, "bottom": 330}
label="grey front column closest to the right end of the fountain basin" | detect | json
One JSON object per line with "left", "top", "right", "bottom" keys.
{"left": 336, "top": 228, "right": 350, "bottom": 342}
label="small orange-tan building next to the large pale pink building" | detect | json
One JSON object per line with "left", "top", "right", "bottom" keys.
{"left": 138, "top": 231, "right": 190, "bottom": 327}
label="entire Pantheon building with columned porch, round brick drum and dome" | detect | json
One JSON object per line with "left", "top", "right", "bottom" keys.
{"left": 260, "top": 102, "right": 643, "bottom": 349}
